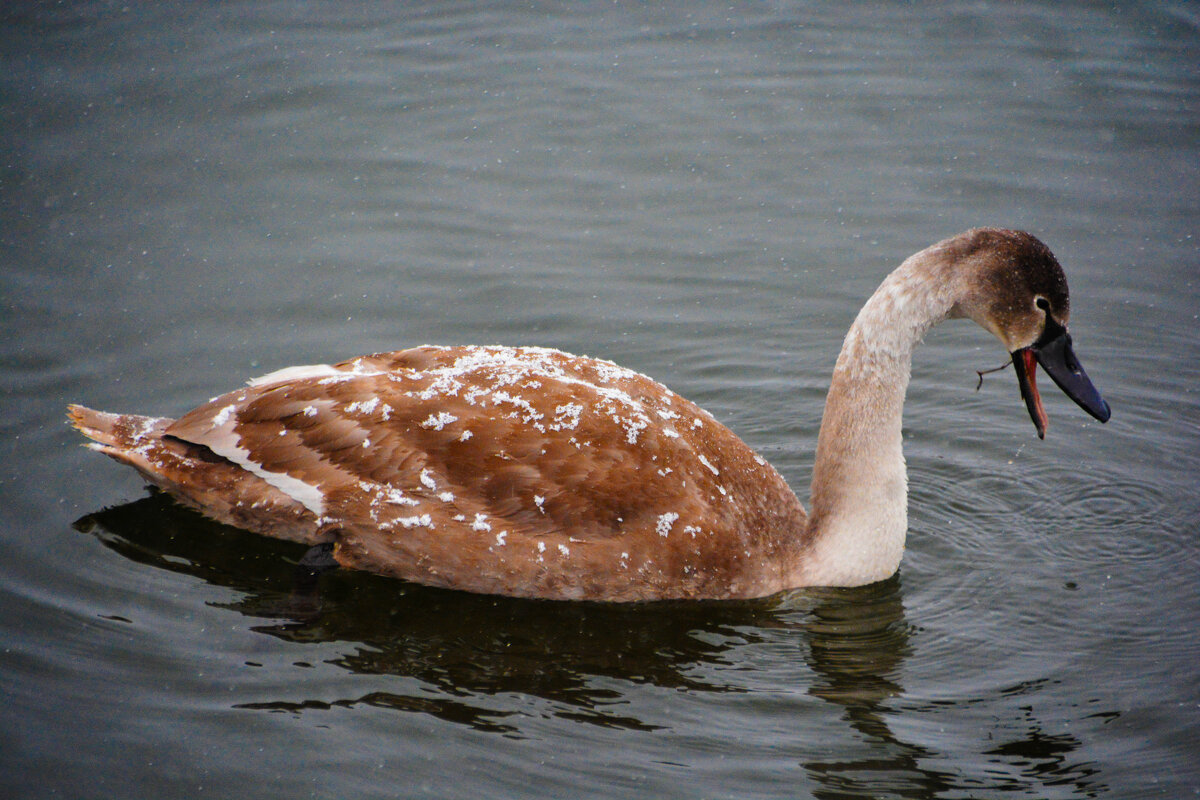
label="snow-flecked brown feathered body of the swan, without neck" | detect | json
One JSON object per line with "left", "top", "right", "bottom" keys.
{"left": 72, "top": 347, "right": 804, "bottom": 600}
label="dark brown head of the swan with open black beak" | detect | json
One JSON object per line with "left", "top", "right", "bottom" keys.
{"left": 938, "top": 228, "right": 1111, "bottom": 439}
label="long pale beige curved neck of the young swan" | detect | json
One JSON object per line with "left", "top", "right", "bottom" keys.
{"left": 798, "top": 248, "right": 954, "bottom": 585}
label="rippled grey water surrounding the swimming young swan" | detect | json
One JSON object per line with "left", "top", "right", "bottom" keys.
{"left": 0, "top": 1, "right": 1200, "bottom": 798}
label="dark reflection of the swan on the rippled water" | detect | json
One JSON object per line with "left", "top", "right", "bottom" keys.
{"left": 76, "top": 494, "right": 1103, "bottom": 796}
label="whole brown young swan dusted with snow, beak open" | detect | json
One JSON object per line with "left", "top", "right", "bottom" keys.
{"left": 70, "top": 228, "right": 1110, "bottom": 602}
